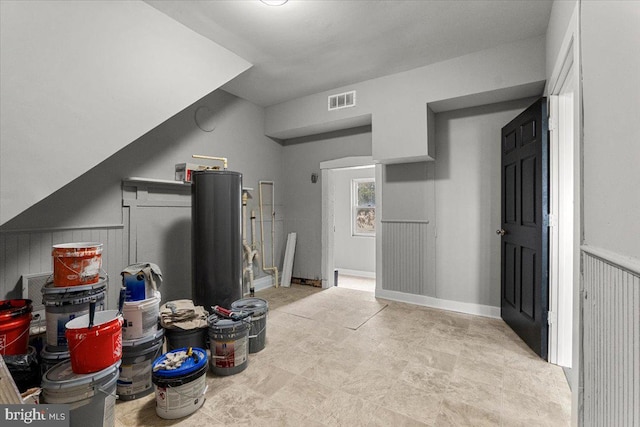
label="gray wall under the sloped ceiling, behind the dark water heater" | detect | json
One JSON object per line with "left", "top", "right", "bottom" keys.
{"left": 0, "top": 90, "right": 282, "bottom": 306}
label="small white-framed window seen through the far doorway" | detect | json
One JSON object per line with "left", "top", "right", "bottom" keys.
{"left": 351, "top": 178, "right": 376, "bottom": 236}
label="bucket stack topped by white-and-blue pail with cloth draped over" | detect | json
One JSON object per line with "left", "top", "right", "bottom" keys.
{"left": 117, "top": 263, "right": 164, "bottom": 400}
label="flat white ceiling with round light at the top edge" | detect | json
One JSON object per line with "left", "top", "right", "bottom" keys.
{"left": 147, "top": 0, "right": 551, "bottom": 106}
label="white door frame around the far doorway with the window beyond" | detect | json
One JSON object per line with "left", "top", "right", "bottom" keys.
{"left": 320, "top": 156, "right": 382, "bottom": 291}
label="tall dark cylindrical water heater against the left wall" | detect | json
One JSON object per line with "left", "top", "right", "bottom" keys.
{"left": 191, "top": 170, "right": 243, "bottom": 312}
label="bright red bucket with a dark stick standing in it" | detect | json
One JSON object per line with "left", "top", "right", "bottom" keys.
{"left": 65, "top": 310, "right": 122, "bottom": 374}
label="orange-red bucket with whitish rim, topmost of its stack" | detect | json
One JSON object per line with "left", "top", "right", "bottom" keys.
{"left": 51, "top": 242, "right": 102, "bottom": 286}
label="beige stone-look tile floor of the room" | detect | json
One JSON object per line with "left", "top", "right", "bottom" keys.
{"left": 116, "top": 286, "right": 571, "bottom": 426}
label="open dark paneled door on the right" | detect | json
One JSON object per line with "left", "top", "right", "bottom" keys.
{"left": 498, "top": 98, "right": 549, "bottom": 360}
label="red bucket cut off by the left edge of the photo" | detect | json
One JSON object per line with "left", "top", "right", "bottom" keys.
{"left": 0, "top": 299, "right": 33, "bottom": 356}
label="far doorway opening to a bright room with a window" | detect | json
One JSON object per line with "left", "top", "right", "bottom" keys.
{"left": 320, "top": 156, "right": 379, "bottom": 292}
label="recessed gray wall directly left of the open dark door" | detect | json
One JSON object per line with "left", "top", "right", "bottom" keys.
{"left": 436, "top": 98, "right": 535, "bottom": 307}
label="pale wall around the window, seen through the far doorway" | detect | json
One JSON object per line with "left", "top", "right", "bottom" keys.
{"left": 332, "top": 168, "right": 376, "bottom": 273}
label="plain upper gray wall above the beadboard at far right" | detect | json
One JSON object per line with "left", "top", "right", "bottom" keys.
{"left": 582, "top": 1, "right": 640, "bottom": 260}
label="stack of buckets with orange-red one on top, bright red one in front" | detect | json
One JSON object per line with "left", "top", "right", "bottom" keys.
{"left": 41, "top": 242, "right": 124, "bottom": 426}
